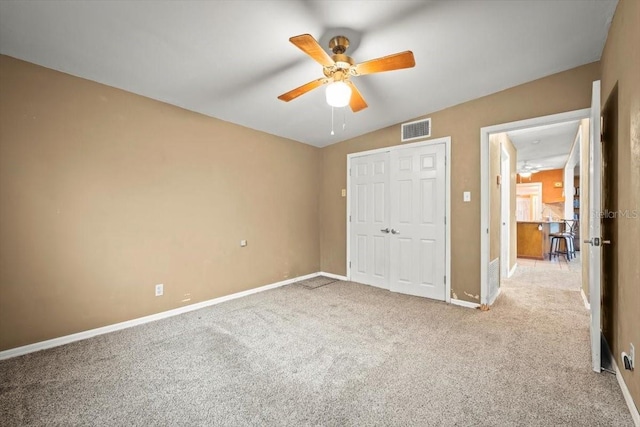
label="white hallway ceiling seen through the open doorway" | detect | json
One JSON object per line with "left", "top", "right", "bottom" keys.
{"left": 507, "top": 120, "right": 580, "bottom": 170}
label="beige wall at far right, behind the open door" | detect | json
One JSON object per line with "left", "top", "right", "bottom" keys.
{"left": 601, "top": 0, "right": 640, "bottom": 406}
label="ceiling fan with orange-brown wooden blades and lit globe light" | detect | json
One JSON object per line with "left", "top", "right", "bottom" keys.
{"left": 278, "top": 34, "right": 416, "bottom": 113}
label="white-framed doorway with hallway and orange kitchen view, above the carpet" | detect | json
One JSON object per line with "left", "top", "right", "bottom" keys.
{"left": 481, "top": 109, "right": 590, "bottom": 305}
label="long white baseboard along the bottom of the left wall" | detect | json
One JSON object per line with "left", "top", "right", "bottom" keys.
{"left": 0, "top": 273, "right": 324, "bottom": 360}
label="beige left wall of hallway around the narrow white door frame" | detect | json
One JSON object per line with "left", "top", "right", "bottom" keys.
{"left": 489, "top": 132, "right": 518, "bottom": 273}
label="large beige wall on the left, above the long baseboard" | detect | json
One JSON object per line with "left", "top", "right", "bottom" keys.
{"left": 0, "top": 56, "right": 321, "bottom": 350}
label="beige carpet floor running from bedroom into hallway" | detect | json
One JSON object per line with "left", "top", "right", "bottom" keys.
{"left": 0, "top": 270, "right": 633, "bottom": 426}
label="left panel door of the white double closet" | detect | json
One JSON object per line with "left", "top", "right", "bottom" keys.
{"left": 349, "top": 153, "right": 389, "bottom": 289}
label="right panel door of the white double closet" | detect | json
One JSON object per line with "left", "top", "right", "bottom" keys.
{"left": 390, "top": 144, "right": 446, "bottom": 300}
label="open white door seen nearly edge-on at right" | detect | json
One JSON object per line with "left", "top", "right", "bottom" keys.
{"left": 585, "top": 80, "right": 602, "bottom": 372}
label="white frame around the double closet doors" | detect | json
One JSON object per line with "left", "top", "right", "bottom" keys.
{"left": 346, "top": 136, "right": 451, "bottom": 302}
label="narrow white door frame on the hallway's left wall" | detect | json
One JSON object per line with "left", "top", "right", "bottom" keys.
{"left": 498, "top": 144, "right": 512, "bottom": 280}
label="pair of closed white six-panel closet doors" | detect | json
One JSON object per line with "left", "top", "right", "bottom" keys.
{"left": 349, "top": 144, "right": 446, "bottom": 300}
